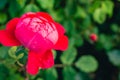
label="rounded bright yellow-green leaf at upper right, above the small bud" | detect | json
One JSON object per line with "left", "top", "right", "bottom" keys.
{"left": 93, "top": 8, "right": 106, "bottom": 24}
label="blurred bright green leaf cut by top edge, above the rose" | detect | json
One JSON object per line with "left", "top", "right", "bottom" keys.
{"left": 37, "top": 0, "right": 54, "bottom": 9}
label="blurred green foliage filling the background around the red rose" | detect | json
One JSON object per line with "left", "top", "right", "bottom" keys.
{"left": 0, "top": 0, "right": 120, "bottom": 80}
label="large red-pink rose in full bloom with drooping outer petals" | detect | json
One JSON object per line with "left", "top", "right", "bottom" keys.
{"left": 0, "top": 12, "right": 68, "bottom": 75}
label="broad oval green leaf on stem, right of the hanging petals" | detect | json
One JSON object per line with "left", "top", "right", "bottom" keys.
{"left": 75, "top": 55, "right": 98, "bottom": 73}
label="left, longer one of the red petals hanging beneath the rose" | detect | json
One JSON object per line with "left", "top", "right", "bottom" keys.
{"left": 26, "top": 51, "right": 39, "bottom": 75}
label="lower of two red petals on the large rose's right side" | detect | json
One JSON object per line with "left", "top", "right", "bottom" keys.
{"left": 54, "top": 35, "right": 68, "bottom": 51}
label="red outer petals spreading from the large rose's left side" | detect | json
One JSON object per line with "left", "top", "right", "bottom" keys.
{"left": 0, "top": 18, "right": 20, "bottom": 46}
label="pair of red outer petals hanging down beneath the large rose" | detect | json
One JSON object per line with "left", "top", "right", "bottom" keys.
{"left": 26, "top": 50, "right": 54, "bottom": 75}
